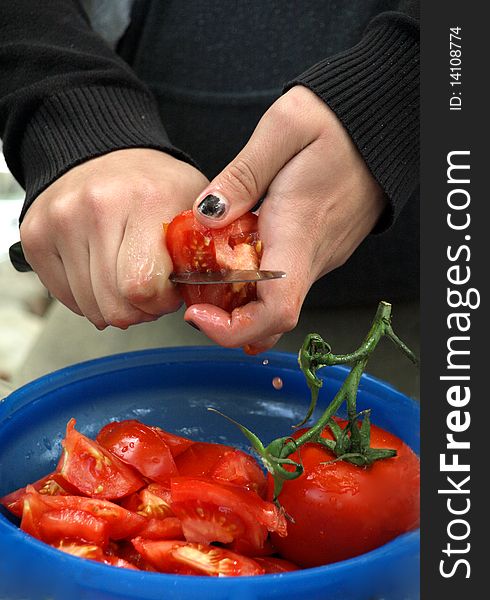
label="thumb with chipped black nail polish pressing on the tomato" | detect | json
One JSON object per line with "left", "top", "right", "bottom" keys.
{"left": 193, "top": 101, "right": 311, "bottom": 228}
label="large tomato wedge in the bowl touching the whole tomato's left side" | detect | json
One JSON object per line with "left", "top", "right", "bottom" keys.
{"left": 171, "top": 477, "right": 286, "bottom": 550}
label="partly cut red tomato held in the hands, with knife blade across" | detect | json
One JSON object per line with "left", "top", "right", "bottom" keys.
{"left": 165, "top": 210, "right": 262, "bottom": 312}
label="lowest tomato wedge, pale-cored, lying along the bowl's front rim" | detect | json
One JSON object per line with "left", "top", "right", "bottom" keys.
{"left": 133, "top": 537, "right": 264, "bottom": 577}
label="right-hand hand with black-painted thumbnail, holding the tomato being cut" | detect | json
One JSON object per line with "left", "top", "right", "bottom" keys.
{"left": 185, "top": 86, "right": 386, "bottom": 352}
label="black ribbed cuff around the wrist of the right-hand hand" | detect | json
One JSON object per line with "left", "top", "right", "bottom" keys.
{"left": 285, "top": 13, "right": 419, "bottom": 232}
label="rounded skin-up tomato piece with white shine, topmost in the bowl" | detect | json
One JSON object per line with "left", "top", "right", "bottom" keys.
{"left": 96, "top": 419, "right": 177, "bottom": 483}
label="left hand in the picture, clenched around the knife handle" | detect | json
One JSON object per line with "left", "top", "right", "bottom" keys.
{"left": 20, "top": 148, "right": 208, "bottom": 329}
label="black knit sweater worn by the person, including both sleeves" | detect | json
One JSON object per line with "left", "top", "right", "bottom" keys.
{"left": 0, "top": 0, "right": 419, "bottom": 304}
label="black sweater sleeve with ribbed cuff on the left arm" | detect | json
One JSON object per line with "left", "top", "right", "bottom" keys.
{"left": 0, "top": 0, "right": 191, "bottom": 220}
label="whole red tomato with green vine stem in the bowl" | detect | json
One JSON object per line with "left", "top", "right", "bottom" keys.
{"left": 269, "top": 425, "right": 420, "bottom": 567}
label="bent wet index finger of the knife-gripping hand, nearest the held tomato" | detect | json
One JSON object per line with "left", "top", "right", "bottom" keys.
{"left": 116, "top": 219, "right": 182, "bottom": 316}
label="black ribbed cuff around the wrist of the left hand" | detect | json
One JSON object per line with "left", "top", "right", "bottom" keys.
{"left": 20, "top": 86, "right": 194, "bottom": 221}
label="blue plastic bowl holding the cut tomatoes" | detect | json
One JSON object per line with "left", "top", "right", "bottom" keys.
{"left": 0, "top": 347, "right": 419, "bottom": 600}
